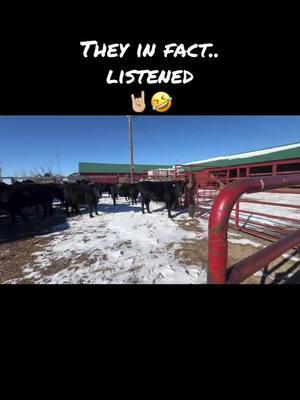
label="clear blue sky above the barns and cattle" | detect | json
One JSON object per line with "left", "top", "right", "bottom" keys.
{"left": 0, "top": 116, "right": 300, "bottom": 176}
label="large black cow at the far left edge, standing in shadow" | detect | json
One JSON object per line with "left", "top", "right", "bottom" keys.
{"left": 0, "top": 183, "right": 53, "bottom": 225}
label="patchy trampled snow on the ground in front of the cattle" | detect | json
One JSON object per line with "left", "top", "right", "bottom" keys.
{"left": 6, "top": 198, "right": 206, "bottom": 284}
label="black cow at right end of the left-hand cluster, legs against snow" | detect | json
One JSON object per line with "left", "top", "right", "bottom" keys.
{"left": 62, "top": 181, "right": 101, "bottom": 218}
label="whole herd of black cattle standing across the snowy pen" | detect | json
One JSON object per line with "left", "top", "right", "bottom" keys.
{"left": 0, "top": 180, "right": 185, "bottom": 225}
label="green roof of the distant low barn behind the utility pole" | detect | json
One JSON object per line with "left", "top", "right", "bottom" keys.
{"left": 79, "top": 162, "right": 172, "bottom": 174}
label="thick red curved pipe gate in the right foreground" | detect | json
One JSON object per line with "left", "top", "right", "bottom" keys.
{"left": 207, "top": 174, "right": 300, "bottom": 283}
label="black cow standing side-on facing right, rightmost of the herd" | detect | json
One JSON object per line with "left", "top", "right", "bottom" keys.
{"left": 137, "top": 181, "right": 181, "bottom": 218}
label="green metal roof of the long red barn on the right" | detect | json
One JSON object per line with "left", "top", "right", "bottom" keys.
{"left": 182, "top": 143, "right": 300, "bottom": 171}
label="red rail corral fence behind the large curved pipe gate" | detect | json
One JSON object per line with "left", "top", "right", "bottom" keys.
{"left": 172, "top": 165, "right": 300, "bottom": 242}
